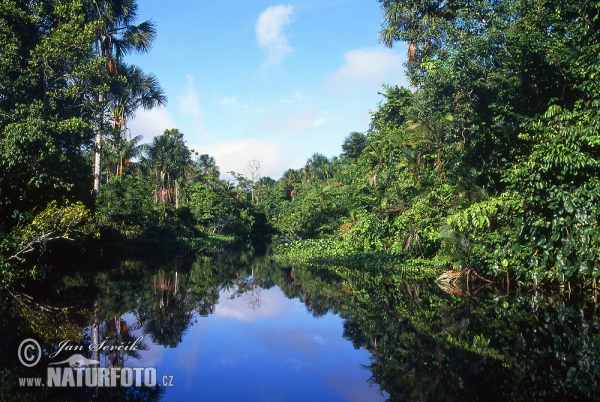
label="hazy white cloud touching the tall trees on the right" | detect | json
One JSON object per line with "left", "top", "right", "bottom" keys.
{"left": 323, "top": 47, "right": 408, "bottom": 94}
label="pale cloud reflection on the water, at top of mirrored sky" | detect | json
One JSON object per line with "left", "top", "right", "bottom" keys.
{"left": 214, "top": 288, "right": 293, "bottom": 322}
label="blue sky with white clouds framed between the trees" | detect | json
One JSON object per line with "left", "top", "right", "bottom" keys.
{"left": 126, "top": 0, "right": 407, "bottom": 179}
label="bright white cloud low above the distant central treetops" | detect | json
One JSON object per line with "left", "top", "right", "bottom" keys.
{"left": 198, "top": 138, "right": 290, "bottom": 179}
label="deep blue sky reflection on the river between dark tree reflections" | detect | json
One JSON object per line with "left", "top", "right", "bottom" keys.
{"left": 128, "top": 287, "right": 385, "bottom": 401}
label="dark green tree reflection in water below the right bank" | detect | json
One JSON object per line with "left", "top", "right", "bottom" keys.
{"left": 278, "top": 266, "right": 600, "bottom": 401}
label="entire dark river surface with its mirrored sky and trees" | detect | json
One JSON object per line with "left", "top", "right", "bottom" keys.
{"left": 0, "top": 243, "right": 600, "bottom": 401}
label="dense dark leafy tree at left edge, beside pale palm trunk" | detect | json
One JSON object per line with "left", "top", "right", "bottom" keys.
{"left": 0, "top": 0, "right": 97, "bottom": 229}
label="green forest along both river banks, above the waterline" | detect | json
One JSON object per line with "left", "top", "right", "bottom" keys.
{"left": 0, "top": 0, "right": 600, "bottom": 286}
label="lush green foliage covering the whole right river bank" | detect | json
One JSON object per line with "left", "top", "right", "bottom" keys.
{"left": 273, "top": 0, "right": 600, "bottom": 284}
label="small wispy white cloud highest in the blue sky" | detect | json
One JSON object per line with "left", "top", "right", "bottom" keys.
{"left": 255, "top": 4, "right": 294, "bottom": 67}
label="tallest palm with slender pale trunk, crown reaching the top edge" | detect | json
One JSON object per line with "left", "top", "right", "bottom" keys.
{"left": 87, "top": 0, "right": 156, "bottom": 194}
